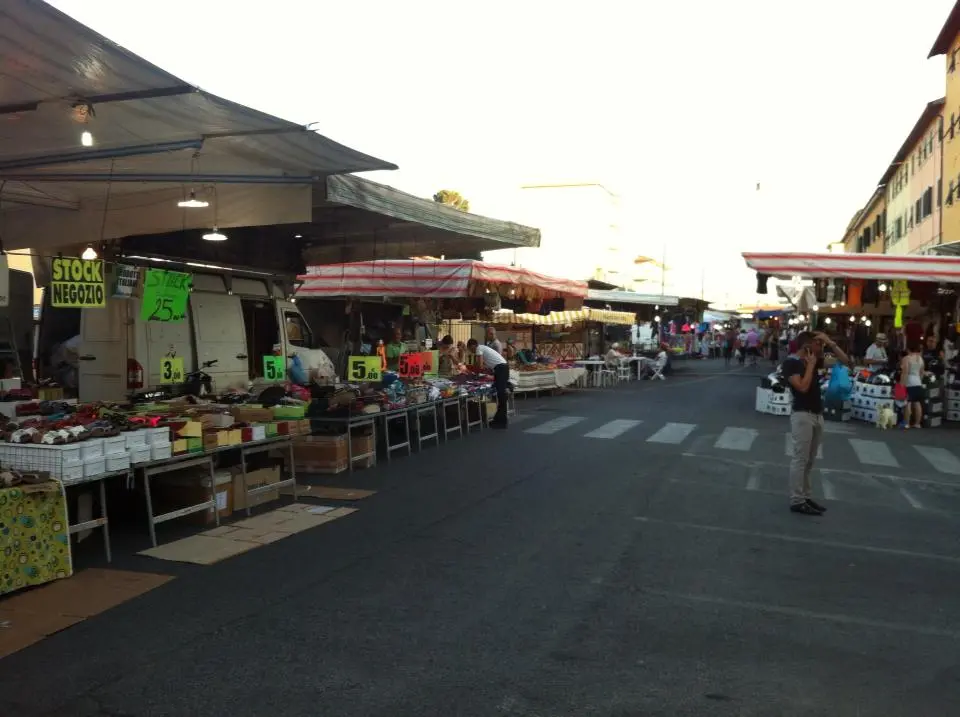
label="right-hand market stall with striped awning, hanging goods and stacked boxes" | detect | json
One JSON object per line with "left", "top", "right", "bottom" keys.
{"left": 743, "top": 253, "right": 960, "bottom": 427}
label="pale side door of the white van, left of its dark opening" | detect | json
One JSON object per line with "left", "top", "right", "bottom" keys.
{"left": 190, "top": 286, "right": 249, "bottom": 391}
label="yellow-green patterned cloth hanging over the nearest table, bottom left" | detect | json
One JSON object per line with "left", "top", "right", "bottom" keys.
{"left": 0, "top": 483, "right": 73, "bottom": 595}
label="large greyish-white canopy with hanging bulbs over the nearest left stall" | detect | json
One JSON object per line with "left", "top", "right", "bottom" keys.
{"left": 0, "top": 0, "right": 396, "bottom": 248}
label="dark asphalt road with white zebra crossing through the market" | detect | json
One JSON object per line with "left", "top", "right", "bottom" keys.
{"left": 0, "top": 369, "right": 960, "bottom": 717}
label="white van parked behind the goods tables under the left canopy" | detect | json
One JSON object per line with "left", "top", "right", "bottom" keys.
{"left": 38, "top": 273, "right": 333, "bottom": 401}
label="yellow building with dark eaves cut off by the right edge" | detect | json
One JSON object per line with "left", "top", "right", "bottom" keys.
{"left": 927, "top": 2, "right": 960, "bottom": 252}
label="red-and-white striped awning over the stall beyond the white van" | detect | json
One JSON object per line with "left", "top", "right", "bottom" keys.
{"left": 297, "top": 259, "right": 587, "bottom": 299}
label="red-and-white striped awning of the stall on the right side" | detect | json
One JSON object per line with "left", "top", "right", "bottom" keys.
{"left": 743, "top": 252, "right": 960, "bottom": 283}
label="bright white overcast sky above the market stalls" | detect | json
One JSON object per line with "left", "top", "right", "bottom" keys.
{"left": 51, "top": 0, "right": 953, "bottom": 300}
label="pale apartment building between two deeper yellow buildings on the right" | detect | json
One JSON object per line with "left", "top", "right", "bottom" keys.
{"left": 880, "top": 98, "right": 940, "bottom": 254}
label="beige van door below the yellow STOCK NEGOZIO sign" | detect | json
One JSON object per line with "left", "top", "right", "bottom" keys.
{"left": 77, "top": 299, "right": 127, "bottom": 402}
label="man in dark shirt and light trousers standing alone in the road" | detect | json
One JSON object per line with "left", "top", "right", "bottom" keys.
{"left": 783, "top": 331, "right": 850, "bottom": 515}
